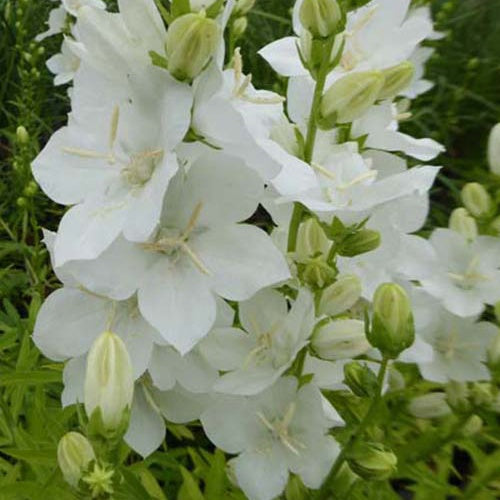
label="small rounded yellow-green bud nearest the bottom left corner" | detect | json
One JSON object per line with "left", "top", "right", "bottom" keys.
{"left": 57, "top": 432, "right": 95, "bottom": 487}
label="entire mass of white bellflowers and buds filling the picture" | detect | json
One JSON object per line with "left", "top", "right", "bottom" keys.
{"left": 33, "top": 0, "right": 500, "bottom": 500}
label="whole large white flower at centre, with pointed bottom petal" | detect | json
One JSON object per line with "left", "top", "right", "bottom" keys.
{"left": 59, "top": 153, "right": 290, "bottom": 354}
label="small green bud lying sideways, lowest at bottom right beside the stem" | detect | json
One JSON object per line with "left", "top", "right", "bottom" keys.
{"left": 348, "top": 443, "right": 398, "bottom": 481}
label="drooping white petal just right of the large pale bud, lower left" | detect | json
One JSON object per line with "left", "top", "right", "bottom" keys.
{"left": 124, "top": 385, "right": 165, "bottom": 457}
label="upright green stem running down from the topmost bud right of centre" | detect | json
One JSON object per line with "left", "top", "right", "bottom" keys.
{"left": 287, "top": 36, "right": 335, "bottom": 252}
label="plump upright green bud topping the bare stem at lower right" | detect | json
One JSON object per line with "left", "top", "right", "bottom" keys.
{"left": 368, "top": 283, "right": 415, "bottom": 358}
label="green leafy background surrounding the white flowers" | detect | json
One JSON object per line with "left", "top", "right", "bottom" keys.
{"left": 0, "top": 0, "right": 500, "bottom": 500}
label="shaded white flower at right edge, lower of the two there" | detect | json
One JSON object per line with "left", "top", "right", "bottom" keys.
{"left": 414, "top": 301, "right": 498, "bottom": 383}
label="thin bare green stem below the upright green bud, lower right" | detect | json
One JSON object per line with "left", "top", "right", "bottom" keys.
{"left": 314, "top": 358, "right": 389, "bottom": 500}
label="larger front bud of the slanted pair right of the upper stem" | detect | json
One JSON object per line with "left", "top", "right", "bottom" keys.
{"left": 318, "top": 71, "right": 385, "bottom": 129}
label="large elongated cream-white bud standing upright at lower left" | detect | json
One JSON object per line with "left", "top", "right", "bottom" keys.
{"left": 84, "top": 332, "right": 134, "bottom": 430}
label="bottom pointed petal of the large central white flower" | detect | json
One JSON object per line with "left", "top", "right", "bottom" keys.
{"left": 138, "top": 257, "right": 217, "bottom": 354}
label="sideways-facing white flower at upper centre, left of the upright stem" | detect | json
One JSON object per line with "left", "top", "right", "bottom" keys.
{"left": 192, "top": 49, "right": 284, "bottom": 180}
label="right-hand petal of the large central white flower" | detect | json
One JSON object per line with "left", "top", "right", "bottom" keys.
{"left": 192, "top": 224, "right": 290, "bottom": 300}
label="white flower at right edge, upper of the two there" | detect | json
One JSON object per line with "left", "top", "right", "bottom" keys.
{"left": 397, "top": 229, "right": 500, "bottom": 317}
